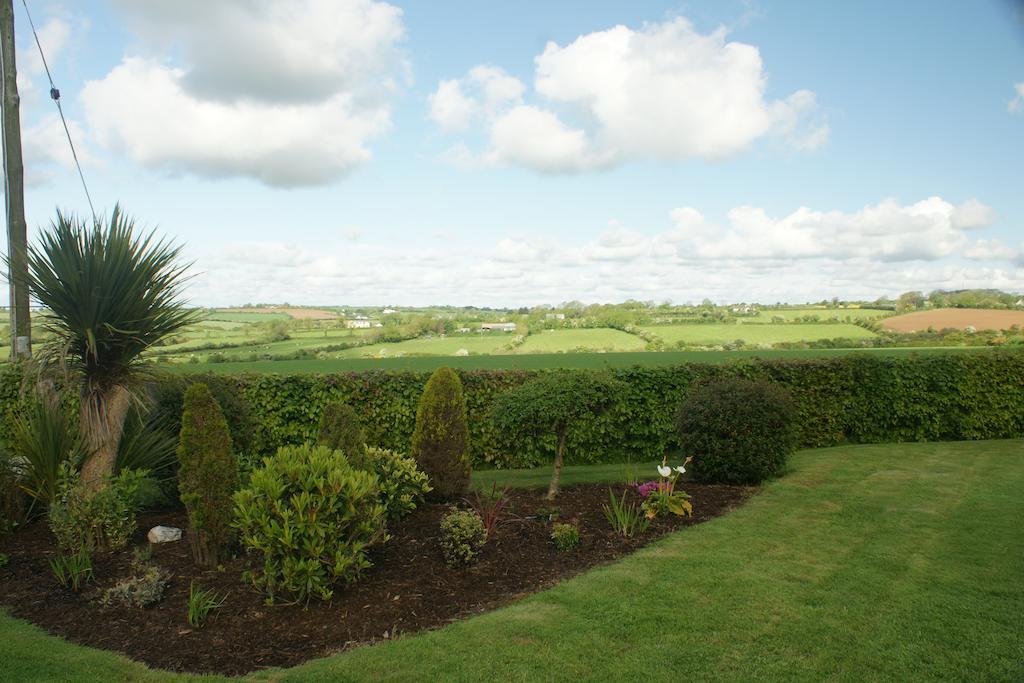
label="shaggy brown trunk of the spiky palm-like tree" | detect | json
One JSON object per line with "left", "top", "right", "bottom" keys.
{"left": 79, "top": 386, "right": 131, "bottom": 492}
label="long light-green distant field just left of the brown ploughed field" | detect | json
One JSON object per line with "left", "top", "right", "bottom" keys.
{"left": 641, "top": 323, "right": 876, "bottom": 345}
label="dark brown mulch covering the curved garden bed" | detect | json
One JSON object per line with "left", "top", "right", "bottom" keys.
{"left": 0, "top": 484, "right": 754, "bottom": 674}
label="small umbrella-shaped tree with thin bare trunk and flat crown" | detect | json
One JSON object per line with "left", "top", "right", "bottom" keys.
{"left": 490, "top": 371, "right": 622, "bottom": 501}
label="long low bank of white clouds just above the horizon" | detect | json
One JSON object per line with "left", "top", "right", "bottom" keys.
{"left": 180, "top": 198, "right": 1024, "bottom": 306}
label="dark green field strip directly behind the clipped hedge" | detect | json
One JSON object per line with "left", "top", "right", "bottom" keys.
{"left": 166, "top": 346, "right": 992, "bottom": 373}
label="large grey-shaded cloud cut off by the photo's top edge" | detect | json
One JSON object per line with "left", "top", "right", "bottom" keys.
{"left": 81, "top": 0, "right": 407, "bottom": 187}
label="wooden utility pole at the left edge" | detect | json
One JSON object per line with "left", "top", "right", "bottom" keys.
{"left": 0, "top": 0, "right": 32, "bottom": 359}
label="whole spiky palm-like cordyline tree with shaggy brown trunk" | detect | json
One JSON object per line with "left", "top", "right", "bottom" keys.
{"left": 22, "top": 207, "right": 197, "bottom": 488}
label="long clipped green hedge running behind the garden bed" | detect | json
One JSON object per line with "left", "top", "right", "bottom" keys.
{"left": 0, "top": 350, "right": 1024, "bottom": 467}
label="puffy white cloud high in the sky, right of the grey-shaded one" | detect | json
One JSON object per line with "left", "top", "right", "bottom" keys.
{"left": 430, "top": 17, "right": 828, "bottom": 172}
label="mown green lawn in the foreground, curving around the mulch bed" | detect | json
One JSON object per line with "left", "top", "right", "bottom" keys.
{"left": 0, "top": 440, "right": 1024, "bottom": 681}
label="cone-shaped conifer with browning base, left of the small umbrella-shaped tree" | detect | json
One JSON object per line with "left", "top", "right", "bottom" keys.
{"left": 413, "top": 367, "right": 470, "bottom": 500}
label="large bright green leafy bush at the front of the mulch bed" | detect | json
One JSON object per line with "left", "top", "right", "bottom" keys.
{"left": 234, "top": 445, "right": 387, "bottom": 602}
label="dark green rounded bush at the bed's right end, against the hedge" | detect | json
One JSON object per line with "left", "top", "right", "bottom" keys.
{"left": 677, "top": 379, "right": 797, "bottom": 484}
